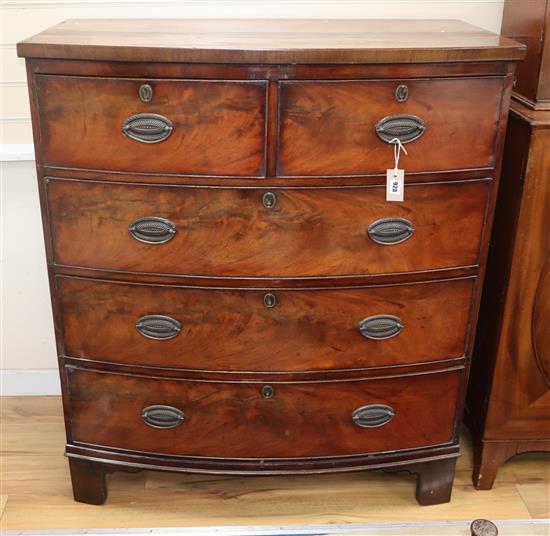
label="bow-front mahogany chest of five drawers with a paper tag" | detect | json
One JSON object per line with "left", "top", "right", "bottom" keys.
{"left": 18, "top": 20, "right": 523, "bottom": 504}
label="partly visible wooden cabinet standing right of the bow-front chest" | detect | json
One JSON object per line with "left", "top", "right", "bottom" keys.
{"left": 467, "top": 1, "right": 550, "bottom": 489}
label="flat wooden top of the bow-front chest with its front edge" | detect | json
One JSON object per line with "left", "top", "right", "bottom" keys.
{"left": 17, "top": 19, "right": 525, "bottom": 64}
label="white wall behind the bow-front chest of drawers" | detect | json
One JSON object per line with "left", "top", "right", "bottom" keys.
{"left": 0, "top": 0, "right": 504, "bottom": 395}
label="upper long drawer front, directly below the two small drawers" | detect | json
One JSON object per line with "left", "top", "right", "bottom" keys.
{"left": 48, "top": 180, "right": 491, "bottom": 277}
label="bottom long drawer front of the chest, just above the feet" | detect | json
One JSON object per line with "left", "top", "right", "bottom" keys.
{"left": 67, "top": 367, "right": 462, "bottom": 458}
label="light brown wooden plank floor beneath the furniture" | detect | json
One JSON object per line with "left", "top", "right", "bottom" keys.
{"left": 0, "top": 397, "right": 550, "bottom": 534}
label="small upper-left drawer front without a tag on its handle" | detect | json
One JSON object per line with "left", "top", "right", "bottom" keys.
{"left": 36, "top": 76, "right": 266, "bottom": 176}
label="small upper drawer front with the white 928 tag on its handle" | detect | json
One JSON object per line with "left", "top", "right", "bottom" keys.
{"left": 279, "top": 78, "right": 502, "bottom": 176}
